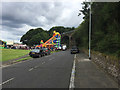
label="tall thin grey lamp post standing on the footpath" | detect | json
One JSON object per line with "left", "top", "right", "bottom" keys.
{"left": 89, "top": 0, "right": 92, "bottom": 59}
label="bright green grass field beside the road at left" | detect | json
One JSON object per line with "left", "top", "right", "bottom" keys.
{"left": 0, "top": 49, "right": 30, "bottom": 61}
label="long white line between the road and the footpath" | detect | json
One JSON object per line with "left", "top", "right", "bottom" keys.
{"left": 69, "top": 54, "right": 76, "bottom": 90}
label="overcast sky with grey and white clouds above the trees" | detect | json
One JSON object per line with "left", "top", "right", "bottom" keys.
{"left": 0, "top": 0, "right": 83, "bottom": 42}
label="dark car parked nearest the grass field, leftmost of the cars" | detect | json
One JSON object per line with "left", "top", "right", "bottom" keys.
{"left": 29, "top": 49, "right": 44, "bottom": 58}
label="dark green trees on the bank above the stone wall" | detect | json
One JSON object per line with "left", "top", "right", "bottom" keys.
{"left": 73, "top": 2, "right": 120, "bottom": 58}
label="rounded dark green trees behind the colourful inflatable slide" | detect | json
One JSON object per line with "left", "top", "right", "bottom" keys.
{"left": 20, "top": 26, "right": 75, "bottom": 46}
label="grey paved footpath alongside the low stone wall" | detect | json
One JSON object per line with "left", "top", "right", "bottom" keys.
{"left": 74, "top": 53, "right": 118, "bottom": 90}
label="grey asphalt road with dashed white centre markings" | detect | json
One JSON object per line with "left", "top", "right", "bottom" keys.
{"left": 0, "top": 51, "right": 74, "bottom": 88}
